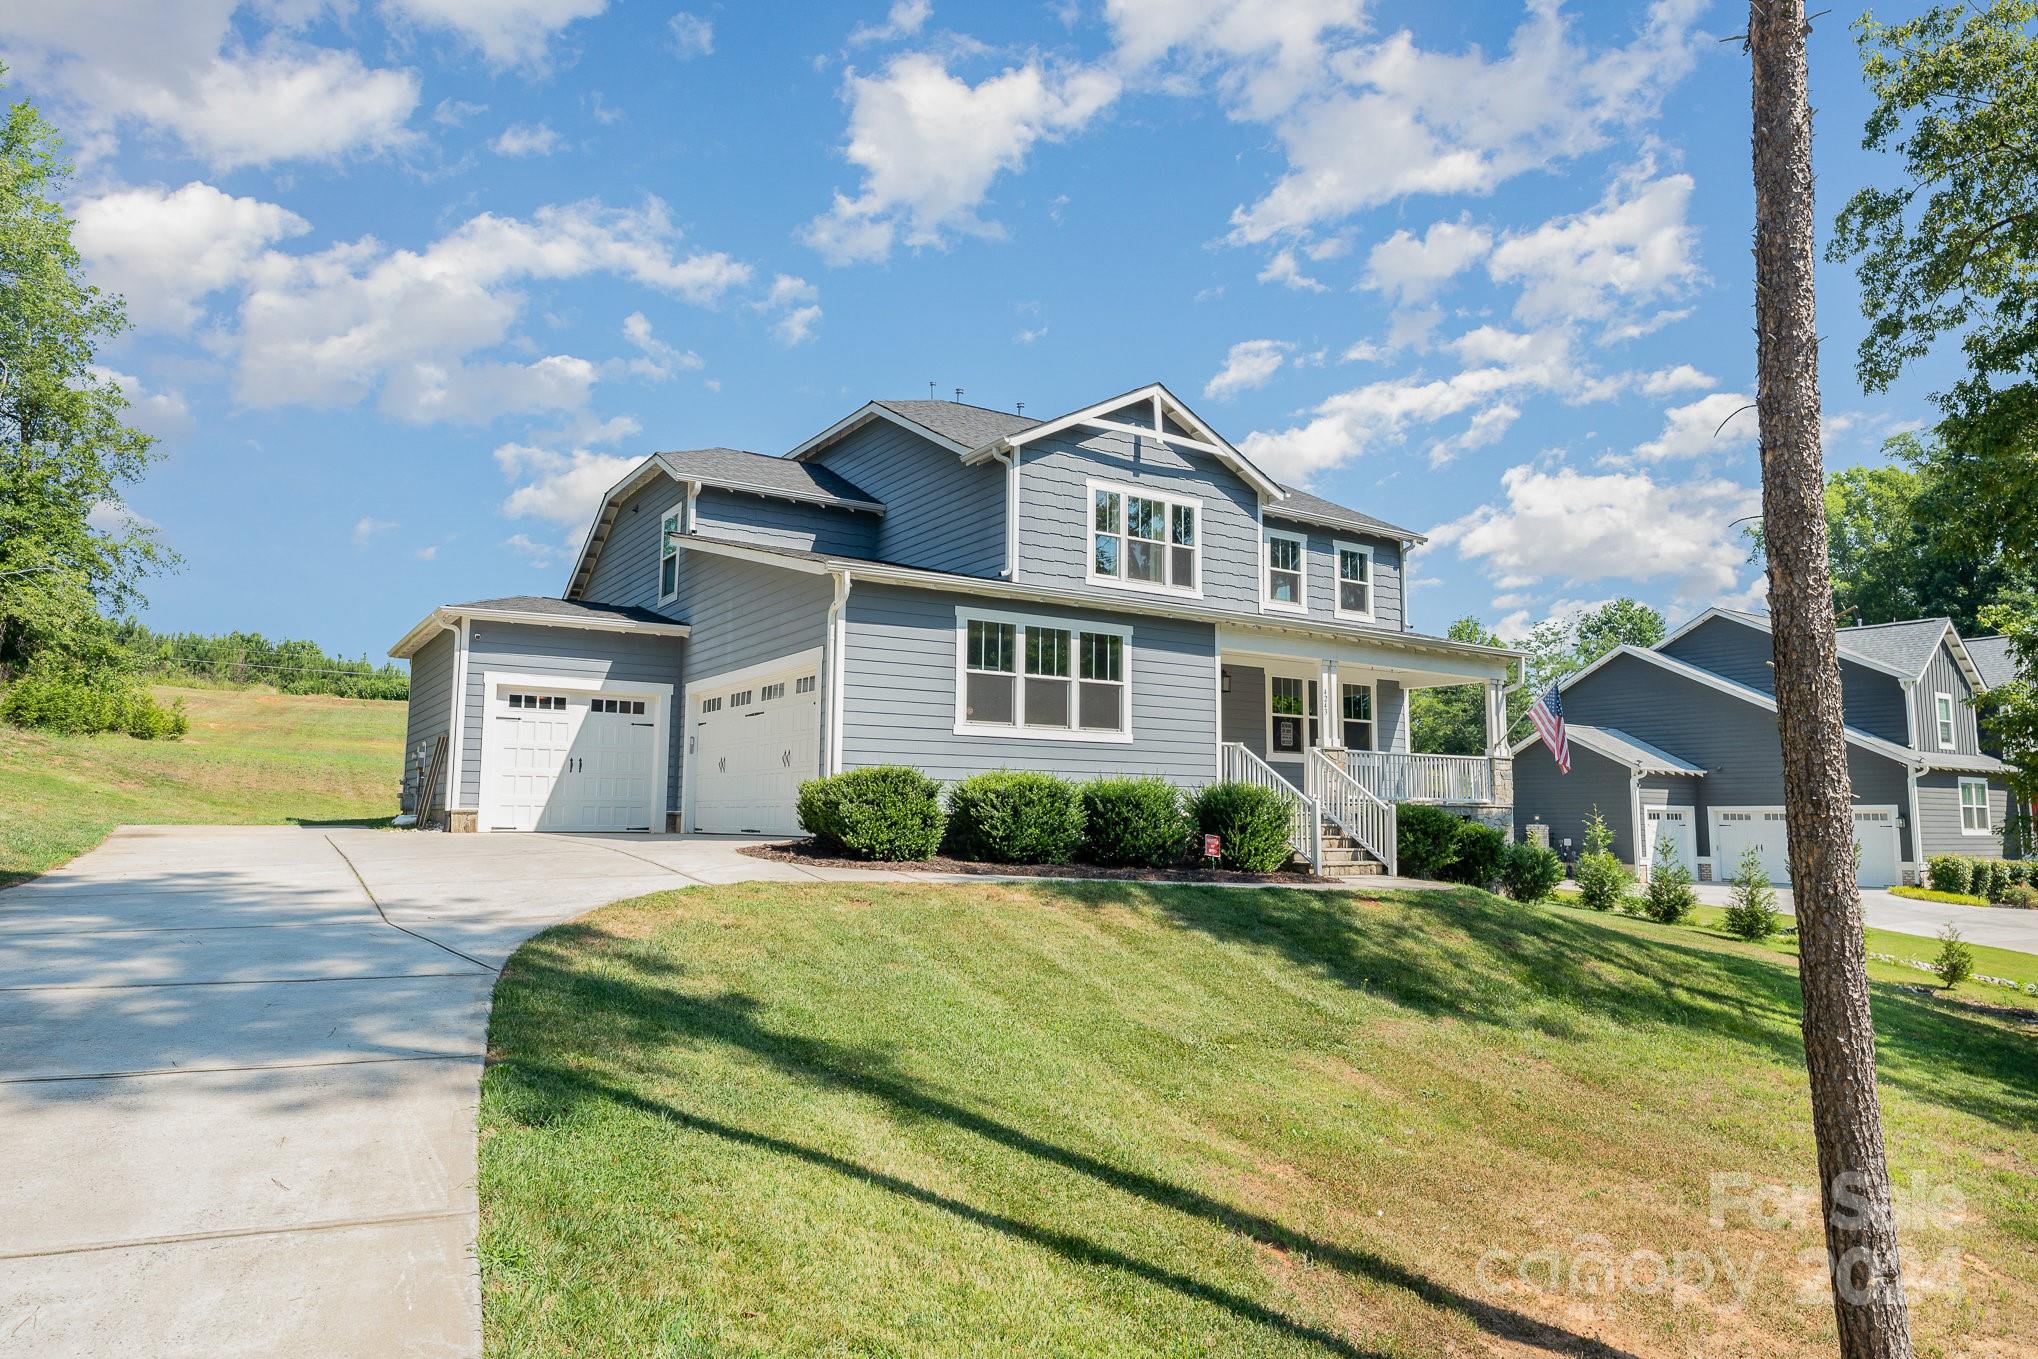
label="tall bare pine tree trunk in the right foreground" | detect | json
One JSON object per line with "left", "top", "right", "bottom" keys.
{"left": 1749, "top": 0, "right": 1918, "bottom": 1359}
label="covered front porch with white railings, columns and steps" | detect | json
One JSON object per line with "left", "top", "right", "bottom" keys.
{"left": 1219, "top": 628, "right": 1514, "bottom": 872}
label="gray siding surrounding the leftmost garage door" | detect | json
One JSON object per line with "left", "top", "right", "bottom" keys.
{"left": 461, "top": 623, "right": 687, "bottom": 814}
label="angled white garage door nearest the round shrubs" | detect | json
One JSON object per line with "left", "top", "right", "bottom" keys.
{"left": 689, "top": 666, "right": 821, "bottom": 835}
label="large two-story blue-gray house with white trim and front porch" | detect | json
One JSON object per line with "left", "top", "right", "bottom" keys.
{"left": 391, "top": 385, "right": 1516, "bottom": 862}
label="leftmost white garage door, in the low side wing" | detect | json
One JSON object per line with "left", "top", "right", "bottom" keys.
{"left": 481, "top": 683, "right": 660, "bottom": 831}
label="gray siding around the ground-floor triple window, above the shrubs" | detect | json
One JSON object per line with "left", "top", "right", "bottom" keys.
{"left": 842, "top": 585, "right": 1217, "bottom": 786}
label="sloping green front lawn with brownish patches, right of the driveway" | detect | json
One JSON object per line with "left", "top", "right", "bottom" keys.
{"left": 481, "top": 884, "right": 2038, "bottom": 1357}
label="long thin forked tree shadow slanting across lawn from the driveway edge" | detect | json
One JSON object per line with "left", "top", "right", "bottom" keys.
{"left": 487, "top": 925, "right": 1628, "bottom": 1359}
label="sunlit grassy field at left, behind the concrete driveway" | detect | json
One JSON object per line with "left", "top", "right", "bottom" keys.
{"left": 0, "top": 689, "right": 406, "bottom": 886}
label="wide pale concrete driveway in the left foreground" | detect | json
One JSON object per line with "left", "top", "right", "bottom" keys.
{"left": 0, "top": 827, "right": 850, "bottom": 1359}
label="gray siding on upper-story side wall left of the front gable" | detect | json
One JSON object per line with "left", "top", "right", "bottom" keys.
{"left": 817, "top": 420, "right": 1005, "bottom": 577}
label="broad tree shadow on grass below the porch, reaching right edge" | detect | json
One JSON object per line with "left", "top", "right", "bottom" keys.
{"left": 1100, "top": 884, "right": 2038, "bottom": 1131}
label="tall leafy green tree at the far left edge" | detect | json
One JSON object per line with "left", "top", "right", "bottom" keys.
{"left": 0, "top": 67, "right": 173, "bottom": 674}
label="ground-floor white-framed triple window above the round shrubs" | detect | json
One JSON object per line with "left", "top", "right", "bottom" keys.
{"left": 956, "top": 609, "right": 1131, "bottom": 742}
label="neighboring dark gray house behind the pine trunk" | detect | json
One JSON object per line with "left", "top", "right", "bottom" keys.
{"left": 1514, "top": 609, "right": 2009, "bottom": 886}
